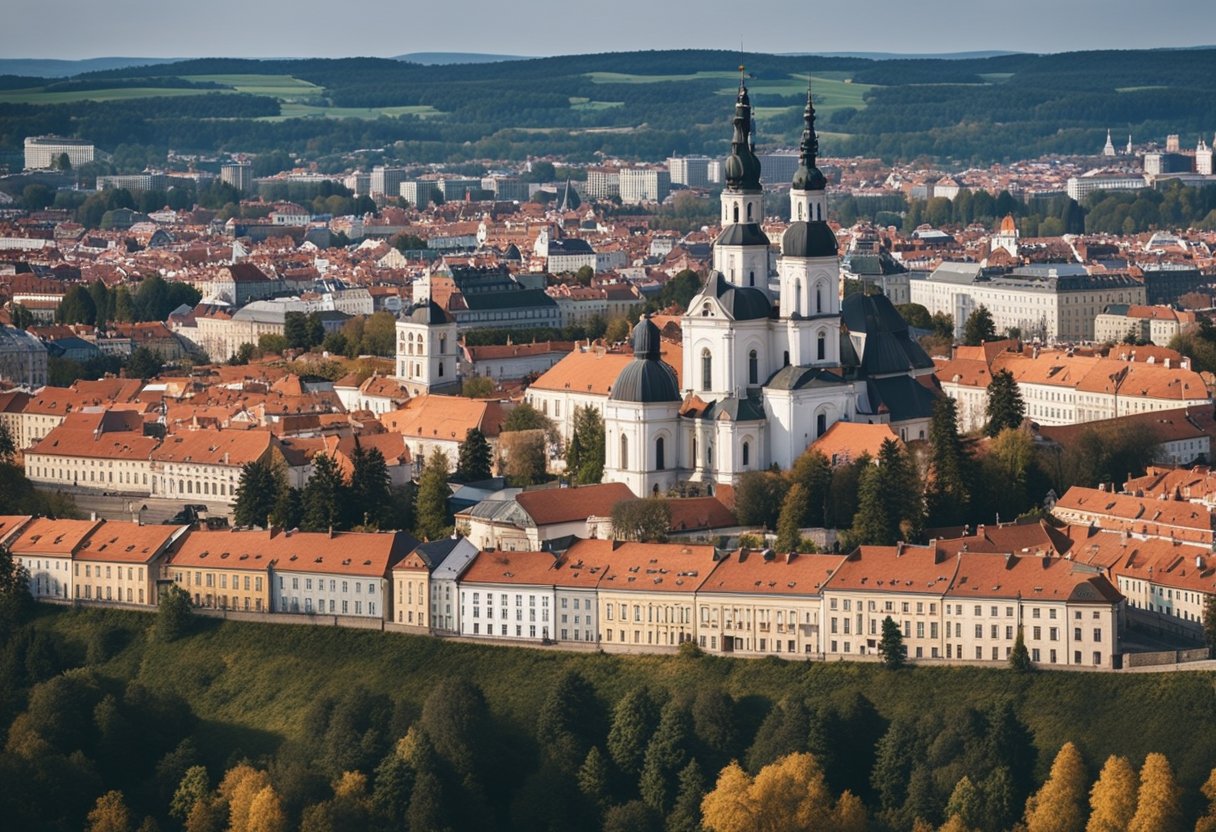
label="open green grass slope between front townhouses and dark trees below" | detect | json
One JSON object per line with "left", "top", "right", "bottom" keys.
{"left": 36, "top": 600, "right": 1216, "bottom": 791}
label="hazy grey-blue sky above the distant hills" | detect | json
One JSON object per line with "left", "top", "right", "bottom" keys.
{"left": 0, "top": 0, "right": 1216, "bottom": 58}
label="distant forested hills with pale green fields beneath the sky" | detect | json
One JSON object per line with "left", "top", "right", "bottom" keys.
{"left": 0, "top": 49, "right": 1216, "bottom": 163}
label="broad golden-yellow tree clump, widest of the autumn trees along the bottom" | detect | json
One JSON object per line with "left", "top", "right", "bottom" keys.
{"left": 700, "top": 753, "right": 866, "bottom": 832}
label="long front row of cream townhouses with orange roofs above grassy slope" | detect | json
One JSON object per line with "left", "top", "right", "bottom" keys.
{"left": 0, "top": 517, "right": 1157, "bottom": 668}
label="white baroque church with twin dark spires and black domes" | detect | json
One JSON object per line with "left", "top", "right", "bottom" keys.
{"left": 603, "top": 80, "right": 941, "bottom": 495}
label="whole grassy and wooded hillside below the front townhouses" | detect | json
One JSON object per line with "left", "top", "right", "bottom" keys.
{"left": 0, "top": 608, "right": 1216, "bottom": 832}
